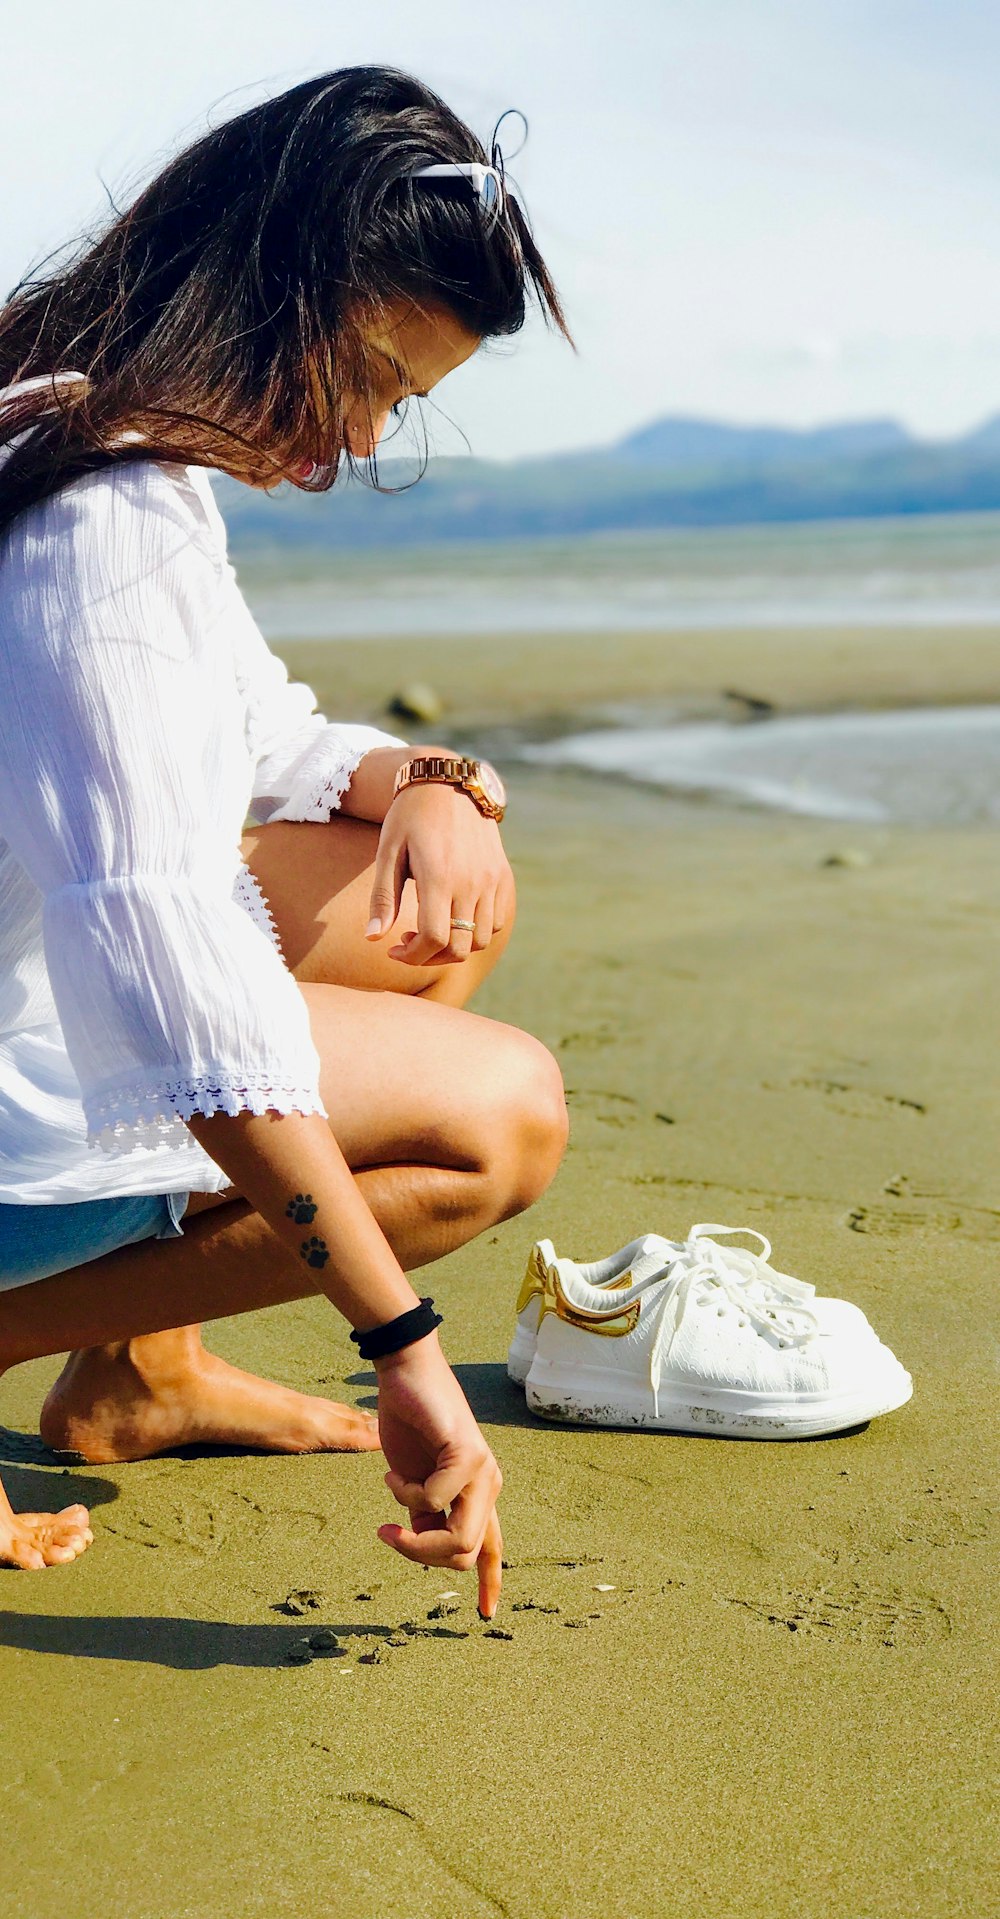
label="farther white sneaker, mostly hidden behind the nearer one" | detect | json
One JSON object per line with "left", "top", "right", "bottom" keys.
{"left": 507, "top": 1226, "right": 877, "bottom": 1386}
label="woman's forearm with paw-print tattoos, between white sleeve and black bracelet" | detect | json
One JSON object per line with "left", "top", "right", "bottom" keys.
{"left": 186, "top": 1113, "right": 418, "bottom": 1332}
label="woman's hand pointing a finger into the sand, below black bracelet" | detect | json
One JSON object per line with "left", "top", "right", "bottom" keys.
{"left": 374, "top": 1334, "right": 503, "bottom": 1620}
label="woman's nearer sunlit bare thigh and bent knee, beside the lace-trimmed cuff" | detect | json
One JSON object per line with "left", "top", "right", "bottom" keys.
{"left": 188, "top": 983, "right": 566, "bottom": 1215}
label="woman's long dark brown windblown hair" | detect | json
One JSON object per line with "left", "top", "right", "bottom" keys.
{"left": 0, "top": 67, "right": 570, "bottom": 533}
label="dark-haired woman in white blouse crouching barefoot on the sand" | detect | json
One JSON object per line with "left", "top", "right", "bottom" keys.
{"left": 0, "top": 67, "right": 566, "bottom": 1616}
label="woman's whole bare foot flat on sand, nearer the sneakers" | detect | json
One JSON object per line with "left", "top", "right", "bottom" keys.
{"left": 38, "top": 1328, "right": 378, "bottom": 1464}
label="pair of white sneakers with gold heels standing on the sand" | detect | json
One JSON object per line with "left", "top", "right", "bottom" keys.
{"left": 510, "top": 1226, "right": 914, "bottom": 1439}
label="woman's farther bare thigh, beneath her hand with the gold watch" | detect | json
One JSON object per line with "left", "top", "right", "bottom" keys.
{"left": 242, "top": 817, "right": 511, "bottom": 1006}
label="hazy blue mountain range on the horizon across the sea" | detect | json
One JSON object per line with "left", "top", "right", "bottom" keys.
{"left": 217, "top": 404, "right": 1000, "bottom": 555}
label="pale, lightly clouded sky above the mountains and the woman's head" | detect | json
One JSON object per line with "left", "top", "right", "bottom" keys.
{"left": 0, "top": 0, "right": 1000, "bottom": 459}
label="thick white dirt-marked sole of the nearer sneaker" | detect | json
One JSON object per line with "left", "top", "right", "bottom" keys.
{"left": 524, "top": 1355, "right": 914, "bottom": 1439}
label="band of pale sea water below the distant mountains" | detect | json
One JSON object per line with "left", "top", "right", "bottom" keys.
{"left": 238, "top": 514, "right": 1000, "bottom": 639}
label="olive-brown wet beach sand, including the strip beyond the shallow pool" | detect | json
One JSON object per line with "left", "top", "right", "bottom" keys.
{"left": 0, "top": 633, "right": 1000, "bottom": 1919}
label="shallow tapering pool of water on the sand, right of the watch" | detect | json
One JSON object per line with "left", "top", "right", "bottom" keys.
{"left": 520, "top": 706, "right": 1000, "bottom": 827}
